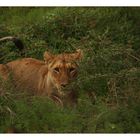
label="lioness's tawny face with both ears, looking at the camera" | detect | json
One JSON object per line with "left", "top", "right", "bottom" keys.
{"left": 44, "top": 50, "right": 82, "bottom": 94}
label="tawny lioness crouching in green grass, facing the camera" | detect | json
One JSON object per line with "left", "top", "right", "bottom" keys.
{"left": 0, "top": 49, "right": 82, "bottom": 103}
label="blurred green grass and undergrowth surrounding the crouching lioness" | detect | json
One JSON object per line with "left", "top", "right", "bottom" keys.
{"left": 0, "top": 7, "right": 140, "bottom": 133}
